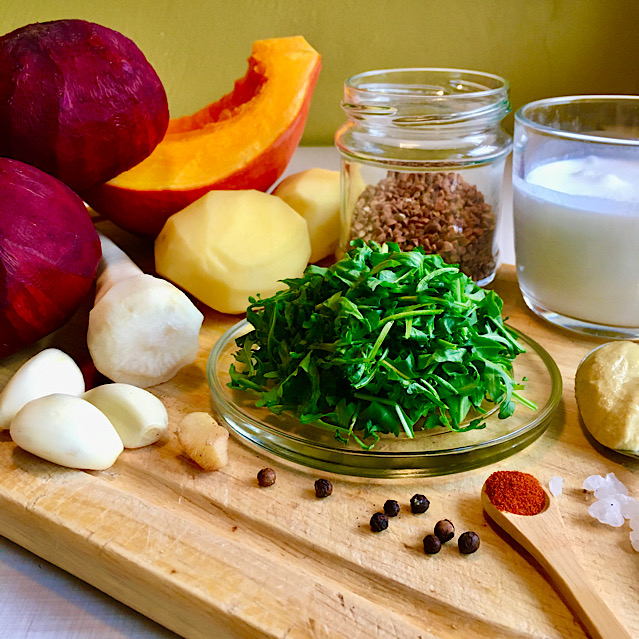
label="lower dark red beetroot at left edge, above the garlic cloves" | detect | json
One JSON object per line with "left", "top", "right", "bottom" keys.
{"left": 0, "top": 158, "right": 102, "bottom": 357}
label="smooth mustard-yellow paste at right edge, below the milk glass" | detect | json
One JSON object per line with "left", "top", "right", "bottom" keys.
{"left": 575, "top": 341, "right": 639, "bottom": 451}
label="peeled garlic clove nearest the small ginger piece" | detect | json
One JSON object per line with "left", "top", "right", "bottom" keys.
{"left": 82, "top": 383, "right": 169, "bottom": 448}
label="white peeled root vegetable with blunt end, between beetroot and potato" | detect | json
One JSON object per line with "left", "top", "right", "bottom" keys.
{"left": 87, "top": 235, "right": 204, "bottom": 388}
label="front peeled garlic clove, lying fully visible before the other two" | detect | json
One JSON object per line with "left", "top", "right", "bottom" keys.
{"left": 9, "top": 393, "right": 124, "bottom": 470}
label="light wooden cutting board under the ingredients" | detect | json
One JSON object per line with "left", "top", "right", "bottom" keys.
{"left": 0, "top": 232, "right": 639, "bottom": 639}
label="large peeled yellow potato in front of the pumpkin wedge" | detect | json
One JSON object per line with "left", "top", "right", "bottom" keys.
{"left": 155, "top": 191, "right": 311, "bottom": 313}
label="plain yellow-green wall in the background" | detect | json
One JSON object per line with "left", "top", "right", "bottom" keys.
{"left": 0, "top": 0, "right": 639, "bottom": 145}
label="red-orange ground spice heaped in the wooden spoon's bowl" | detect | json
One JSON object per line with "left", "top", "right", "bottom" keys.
{"left": 484, "top": 470, "right": 546, "bottom": 515}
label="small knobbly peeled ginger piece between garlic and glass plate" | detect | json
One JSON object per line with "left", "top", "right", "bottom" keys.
{"left": 175, "top": 412, "right": 229, "bottom": 470}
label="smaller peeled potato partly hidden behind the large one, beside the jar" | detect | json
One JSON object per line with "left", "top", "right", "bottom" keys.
{"left": 273, "top": 168, "right": 340, "bottom": 262}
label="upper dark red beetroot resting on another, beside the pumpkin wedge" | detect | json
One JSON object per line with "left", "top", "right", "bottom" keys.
{"left": 0, "top": 20, "right": 169, "bottom": 191}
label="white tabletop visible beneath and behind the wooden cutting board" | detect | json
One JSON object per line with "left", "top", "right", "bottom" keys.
{"left": 0, "top": 147, "right": 514, "bottom": 639}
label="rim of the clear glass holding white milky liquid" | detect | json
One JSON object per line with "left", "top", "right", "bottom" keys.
{"left": 515, "top": 94, "right": 639, "bottom": 147}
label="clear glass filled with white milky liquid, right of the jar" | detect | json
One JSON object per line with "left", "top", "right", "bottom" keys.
{"left": 513, "top": 95, "right": 639, "bottom": 339}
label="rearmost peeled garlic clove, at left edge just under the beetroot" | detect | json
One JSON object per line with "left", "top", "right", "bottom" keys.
{"left": 0, "top": 348, "right": 85, "bottom": 430}
